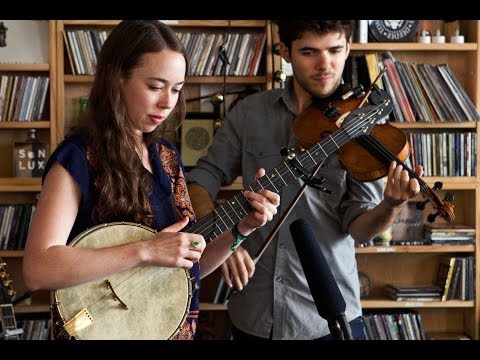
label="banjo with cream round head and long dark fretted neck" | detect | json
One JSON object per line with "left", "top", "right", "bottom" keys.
{"left": 52, "top": 95, "right": 392, "bottom": 340}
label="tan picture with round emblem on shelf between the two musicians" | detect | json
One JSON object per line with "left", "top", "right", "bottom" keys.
{"left": 180, "top": 113, "right": 217, "bottom": 169}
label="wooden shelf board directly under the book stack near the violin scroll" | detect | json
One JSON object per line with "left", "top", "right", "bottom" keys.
{"left": 355, "top": 245, "right": 475, "bottom": 254}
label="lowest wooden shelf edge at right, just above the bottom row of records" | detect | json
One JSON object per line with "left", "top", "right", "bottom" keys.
{"left": 362, "top": 299, "right": 475, "bottom": 309}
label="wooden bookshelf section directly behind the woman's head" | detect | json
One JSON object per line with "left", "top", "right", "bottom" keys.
{"left": 56, "top": 20, "right": 272, "bottom": 143}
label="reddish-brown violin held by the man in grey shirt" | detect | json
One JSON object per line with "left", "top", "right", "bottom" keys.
{"left": 292, "top": 82, "right": 455, "bottom": 222}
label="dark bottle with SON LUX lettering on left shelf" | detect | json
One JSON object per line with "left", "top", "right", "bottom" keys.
{"left": 13, "top": 129, "right": 48, "bottom": 178}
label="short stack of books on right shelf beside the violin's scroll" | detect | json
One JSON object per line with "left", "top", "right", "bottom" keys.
{"left": 424, "top": 223, "right": 475, "bottom": 245}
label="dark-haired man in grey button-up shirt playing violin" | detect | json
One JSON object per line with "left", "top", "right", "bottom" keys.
{"left": 188, "top": 19, "right": 423, "bottom": 340}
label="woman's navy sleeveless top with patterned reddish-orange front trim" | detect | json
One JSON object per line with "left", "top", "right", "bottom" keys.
{"left": 43, "top": 135, "right": 200, "bottom": 340}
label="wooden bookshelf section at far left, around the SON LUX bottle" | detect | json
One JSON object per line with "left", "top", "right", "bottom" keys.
{"left": 0, "top": 20, "right": 57, "bottom": 320}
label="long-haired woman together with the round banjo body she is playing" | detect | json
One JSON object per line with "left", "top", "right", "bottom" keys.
{"left": 23, "top": 20, "right": 280, "bottom": 339}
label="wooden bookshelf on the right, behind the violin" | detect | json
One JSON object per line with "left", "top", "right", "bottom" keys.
{"left": 352, "top": 20, "right": 480, "bottom": 340}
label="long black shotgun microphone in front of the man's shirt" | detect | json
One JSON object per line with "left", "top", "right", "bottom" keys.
{"left": 290, "top": 219, "right": 353, "bottom": 340}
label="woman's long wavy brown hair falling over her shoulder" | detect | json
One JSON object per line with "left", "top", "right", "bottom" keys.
{"left": 86, "top": 20, "right": 188, "bottom": 225}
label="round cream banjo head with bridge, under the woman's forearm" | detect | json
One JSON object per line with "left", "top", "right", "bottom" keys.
{"left": 54, "top": 222, "right": 192, "bottom": 340}
